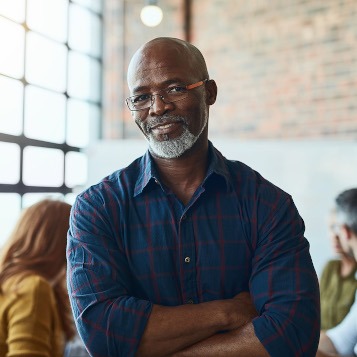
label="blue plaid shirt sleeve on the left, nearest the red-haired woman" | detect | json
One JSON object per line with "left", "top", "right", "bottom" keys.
{"left": 67, "top": 192, "right": 152, "bottom": 357}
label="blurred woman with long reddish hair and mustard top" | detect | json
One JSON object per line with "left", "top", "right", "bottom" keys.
{"left": 0, "top": 199, "right": 75, "bottom": 357}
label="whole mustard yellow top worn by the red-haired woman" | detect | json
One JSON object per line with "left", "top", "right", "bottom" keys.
{"left": 0, "top": 275, "right": 64, "bottom": 357}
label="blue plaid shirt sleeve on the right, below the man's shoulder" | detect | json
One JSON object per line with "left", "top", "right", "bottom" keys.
{"left": 250, "top": 194, "right": 320, "bottom": 357}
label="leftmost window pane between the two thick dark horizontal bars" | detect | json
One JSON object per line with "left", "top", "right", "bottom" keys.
{"left": 0, "top": 142, "right": 20, "bottom": 184}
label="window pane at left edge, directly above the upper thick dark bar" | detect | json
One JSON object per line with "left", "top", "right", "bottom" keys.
{"left": 0, "top": 75, "right": 24, "bottom": 135}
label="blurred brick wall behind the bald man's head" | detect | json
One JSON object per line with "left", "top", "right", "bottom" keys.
{"left": 104, "top": 0, "right": 357, "bottom": 139}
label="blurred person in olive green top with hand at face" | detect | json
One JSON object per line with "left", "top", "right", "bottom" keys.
{"left": 320, "top": 191, "right": 357, "bottom": 330}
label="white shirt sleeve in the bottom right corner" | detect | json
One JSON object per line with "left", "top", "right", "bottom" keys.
{"left": 326, "top": 295, "right": 357, "bottom": 356}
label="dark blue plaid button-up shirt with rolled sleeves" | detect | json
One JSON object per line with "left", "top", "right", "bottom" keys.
{"left": 67, "top": 143, "right": 320, "bottom": 357}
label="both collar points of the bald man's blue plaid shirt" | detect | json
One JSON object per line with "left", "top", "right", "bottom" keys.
{"left": 134, "top": 141, "right": 232, "bottom": 197}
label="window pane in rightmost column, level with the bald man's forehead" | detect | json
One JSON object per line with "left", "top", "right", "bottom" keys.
{"left": 68, "top": 51, "right": 101, "bottom": 102}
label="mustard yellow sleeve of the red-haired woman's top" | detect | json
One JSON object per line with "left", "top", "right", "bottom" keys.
{"left": 7, "top": 277, "right": 54, "bottom": 357}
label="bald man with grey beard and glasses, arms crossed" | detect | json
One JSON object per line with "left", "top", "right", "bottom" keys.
{"left": 67, "top": 38, "right": 320, "bottom": 357}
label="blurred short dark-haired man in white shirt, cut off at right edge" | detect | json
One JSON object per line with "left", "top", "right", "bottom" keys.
{"left": 317, "top": 188, "right": 357, "bottom": 357}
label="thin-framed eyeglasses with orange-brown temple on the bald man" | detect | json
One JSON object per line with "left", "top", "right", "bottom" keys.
{"left": 125, "top": 79, "right": 208, "bottom": 111}
